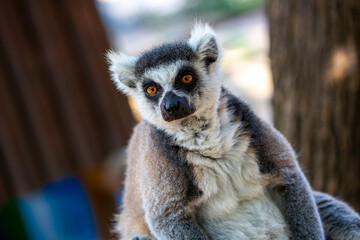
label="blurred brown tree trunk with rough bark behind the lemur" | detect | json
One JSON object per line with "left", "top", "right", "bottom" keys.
{"left": 268, "top": 0, "right": 360, "bottom": 211}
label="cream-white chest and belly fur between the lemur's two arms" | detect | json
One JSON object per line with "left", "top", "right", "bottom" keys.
{"left": 181, "top": 120, "right": 288, "bottom": 239}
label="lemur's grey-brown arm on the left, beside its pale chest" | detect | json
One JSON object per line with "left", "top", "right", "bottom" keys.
{"left": 141, "top": 125, "right": 208, "bottom": 240}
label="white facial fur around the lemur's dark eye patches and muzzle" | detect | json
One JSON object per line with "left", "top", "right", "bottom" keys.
{"left": 133, "top": 60, "right": 222, "bottom": 131}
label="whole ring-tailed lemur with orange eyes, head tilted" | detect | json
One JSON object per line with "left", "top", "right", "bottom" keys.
{"left": 108, "top": 24, "right": 360, "bottom": 240}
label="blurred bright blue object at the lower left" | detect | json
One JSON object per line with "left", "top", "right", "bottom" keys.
{"left": 1, "top": 177, "right": 100, "bottom": 240}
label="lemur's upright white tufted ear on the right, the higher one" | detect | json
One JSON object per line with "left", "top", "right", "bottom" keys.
{"left": 188, "top": 24, "right": 220, "bottom": 71}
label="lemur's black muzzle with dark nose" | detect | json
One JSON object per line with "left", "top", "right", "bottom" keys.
{"left": 161, "top": 92, "right": 195, "bottom": 122}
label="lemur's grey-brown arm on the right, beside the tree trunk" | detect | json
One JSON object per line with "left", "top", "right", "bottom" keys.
{"left": 252, "top": 119, "right": 324, "bottom": 239}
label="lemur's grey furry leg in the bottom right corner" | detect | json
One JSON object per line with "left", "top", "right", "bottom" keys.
{"left": 314, "top": 191, "right": 360, "bottom": 240}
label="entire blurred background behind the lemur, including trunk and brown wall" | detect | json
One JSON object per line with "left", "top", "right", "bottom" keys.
{"left": 0, "top": 0, "right": 360, "bottom": 239}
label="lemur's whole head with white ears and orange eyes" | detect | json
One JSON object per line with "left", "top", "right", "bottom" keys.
{"left": 108, "top": 25, "right": 221, "bottom": 127}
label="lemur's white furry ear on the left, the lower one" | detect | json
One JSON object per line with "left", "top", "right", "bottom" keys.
{"left": 106, "top": 51, "right": 137, "bottom": 95}
